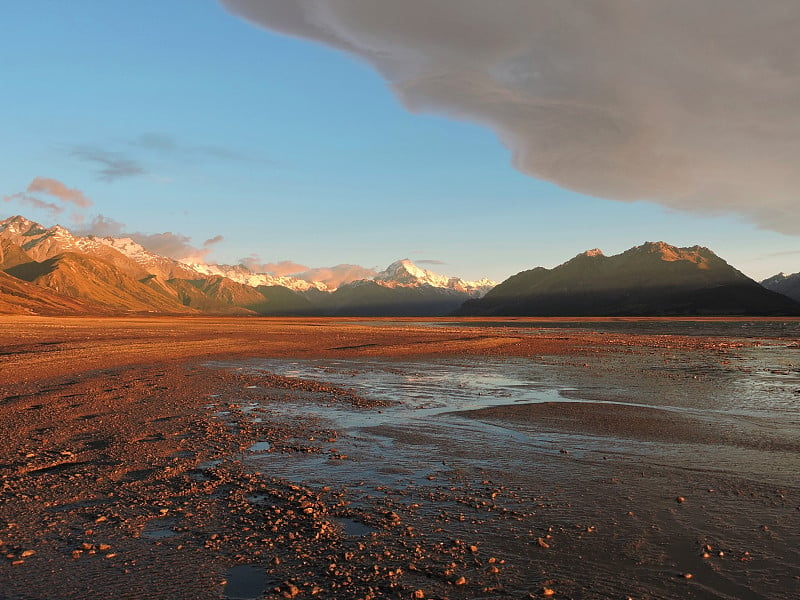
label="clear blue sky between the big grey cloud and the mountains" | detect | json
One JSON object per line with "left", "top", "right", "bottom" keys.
{"left": 0, "top": 0, "right": 800, "bottom": 280}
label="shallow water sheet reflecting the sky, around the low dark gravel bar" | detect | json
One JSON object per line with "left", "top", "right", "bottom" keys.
{"left": 211, "top": 338, "right": 800, "bottom": 482}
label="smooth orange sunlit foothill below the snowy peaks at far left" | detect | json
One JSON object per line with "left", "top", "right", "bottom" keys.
{"left": 7, "top": 252, "right": 194, "bottom": 313}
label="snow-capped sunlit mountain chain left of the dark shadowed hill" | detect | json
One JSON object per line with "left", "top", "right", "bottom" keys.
{"left": 0, "top": 216, "right": 495, "bottom": 316}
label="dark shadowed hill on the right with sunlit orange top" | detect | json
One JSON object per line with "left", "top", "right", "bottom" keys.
{"left": 456, "top": 242, "right": 800, "bottom": 316}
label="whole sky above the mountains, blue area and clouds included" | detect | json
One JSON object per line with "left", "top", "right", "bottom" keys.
{"left": 0, "top": 0, "right": 800, "bottom": 281}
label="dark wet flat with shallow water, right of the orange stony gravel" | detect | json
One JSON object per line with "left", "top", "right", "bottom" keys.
{"left": 208, "top": 332, "right": 800, "bottom": 599}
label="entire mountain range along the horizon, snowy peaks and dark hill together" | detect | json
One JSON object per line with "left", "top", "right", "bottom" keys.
{"left": 0, "top": 216, "right": 800, "bottom": 316}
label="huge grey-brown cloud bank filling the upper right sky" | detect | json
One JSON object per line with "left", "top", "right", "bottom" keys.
{"left": 220, "top": 0, "right": 800, "bottom": 234}
